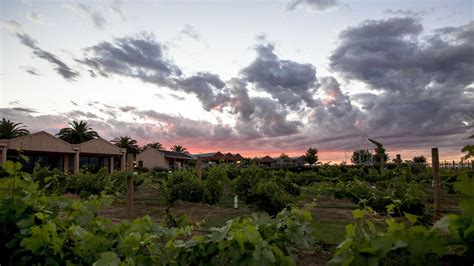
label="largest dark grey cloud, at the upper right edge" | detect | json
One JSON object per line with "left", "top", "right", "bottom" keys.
{"left": 331, "top": 18, "right": 474, "bottom": 93}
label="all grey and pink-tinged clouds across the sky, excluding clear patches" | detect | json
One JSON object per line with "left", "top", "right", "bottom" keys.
{"left": 4, "top": 16, "right": 474, "bottom": 159}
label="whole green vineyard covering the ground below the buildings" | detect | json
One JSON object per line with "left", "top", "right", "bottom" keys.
{"left": 0, "top": 161, "right": 474, "bottom": 265}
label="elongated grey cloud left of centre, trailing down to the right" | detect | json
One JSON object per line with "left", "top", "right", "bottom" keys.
{"left": 79, "top": 33, "right": 229, "bottom": 111}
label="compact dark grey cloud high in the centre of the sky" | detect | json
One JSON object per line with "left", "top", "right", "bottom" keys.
{"left": 241, "top": 44, "right": 317, "bottom": 109}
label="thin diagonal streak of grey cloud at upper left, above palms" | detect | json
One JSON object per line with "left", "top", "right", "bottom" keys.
{"left": 16, "top": 33, "right": 79, "bottom": 81}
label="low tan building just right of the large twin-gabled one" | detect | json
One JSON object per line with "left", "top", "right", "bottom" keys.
{"left": 136, "top": 148, "right": 196, "bottom": 169}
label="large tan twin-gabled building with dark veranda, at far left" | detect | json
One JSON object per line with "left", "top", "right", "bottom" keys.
{"left": 0, "top": 131, "right": 127, "bottom": 174}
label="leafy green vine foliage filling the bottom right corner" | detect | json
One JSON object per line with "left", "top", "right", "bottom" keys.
{"left": 330, "top": 173, "right": 474, "bottom": 265}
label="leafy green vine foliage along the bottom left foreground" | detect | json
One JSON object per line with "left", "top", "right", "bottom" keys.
{"left": 0, "top": 162, "right": 315, "bottom": 265}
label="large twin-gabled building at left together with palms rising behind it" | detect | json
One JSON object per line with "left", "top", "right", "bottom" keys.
{"left": 0, "top": 119, "right": 127, "bottom": 173}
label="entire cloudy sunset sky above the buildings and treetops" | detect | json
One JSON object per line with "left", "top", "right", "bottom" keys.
{"left": 0, "top": 0, "right": 474, "bottom": 162}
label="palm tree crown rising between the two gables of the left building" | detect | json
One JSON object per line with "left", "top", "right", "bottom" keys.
{"left": 56, "top": 120, "right": 99, "bottom": 144}
